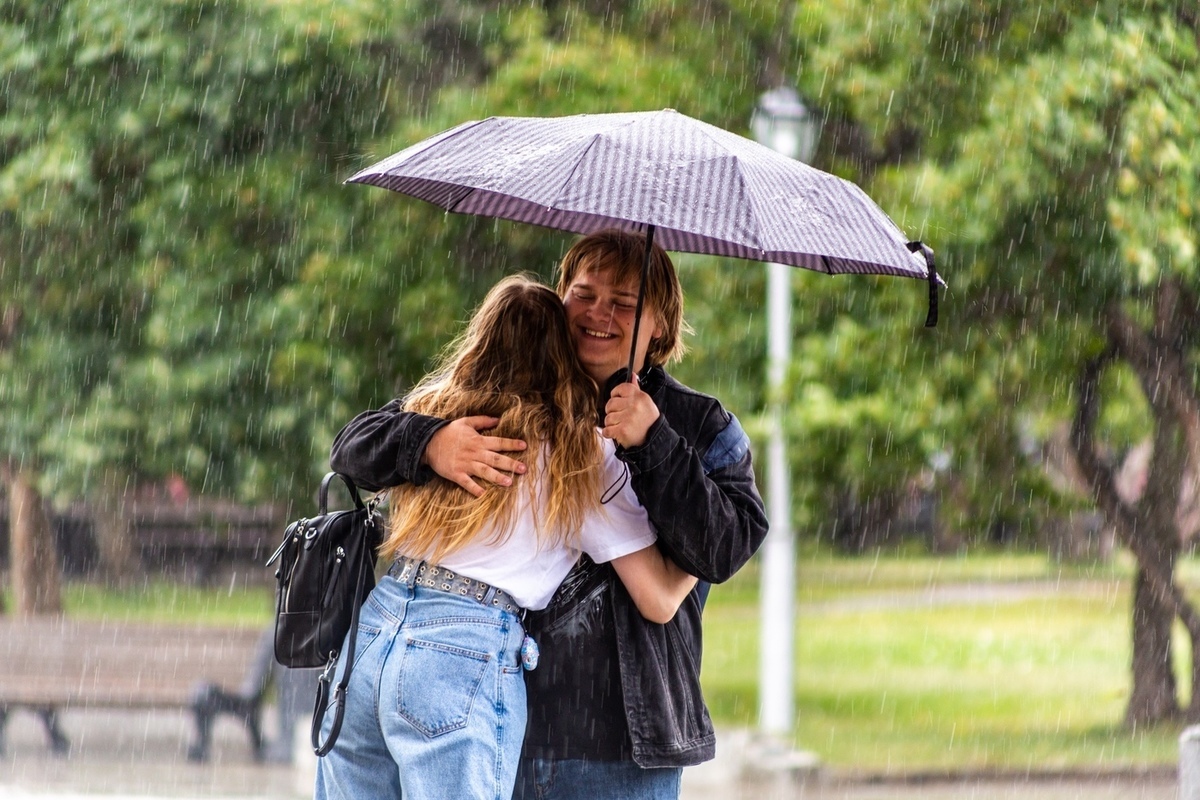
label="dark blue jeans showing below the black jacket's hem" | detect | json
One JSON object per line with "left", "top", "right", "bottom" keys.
{"left": 512, "top": 758, "right": 683, "bottom": 800}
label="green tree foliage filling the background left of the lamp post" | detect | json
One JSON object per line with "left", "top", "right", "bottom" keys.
{"left": 0, "top": 0, "right": 796, "bottom": 513}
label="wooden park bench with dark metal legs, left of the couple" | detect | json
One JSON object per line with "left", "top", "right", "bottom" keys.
{"left": 0, "top": 616, "right": 274, "bottom": 762}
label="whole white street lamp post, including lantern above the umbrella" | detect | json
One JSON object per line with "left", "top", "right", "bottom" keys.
{"left": 750, "top": 88, "right": 821, "bottom": 736}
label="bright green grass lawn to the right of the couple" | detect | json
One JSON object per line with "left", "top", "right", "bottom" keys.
{"left": 703, "top": 554, "right": 1196, "bottom": 774}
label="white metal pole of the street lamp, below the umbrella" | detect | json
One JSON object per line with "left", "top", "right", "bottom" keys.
{"left": 758, "top": 264, "right": 796, "bottom": 735}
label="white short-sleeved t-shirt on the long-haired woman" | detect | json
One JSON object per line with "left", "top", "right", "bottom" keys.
{"left": 432, "top": 439, "right": 658, "bottom": 610}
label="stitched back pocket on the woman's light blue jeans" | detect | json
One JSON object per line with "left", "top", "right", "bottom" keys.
{"left": 396, "top": 638, "right": 491, "bottom": 736}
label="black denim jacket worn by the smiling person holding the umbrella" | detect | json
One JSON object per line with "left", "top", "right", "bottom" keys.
{"left": 330, "top": 367, "right": 767, "bottom": 768}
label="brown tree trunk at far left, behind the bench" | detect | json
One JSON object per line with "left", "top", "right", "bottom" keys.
{"left": 7, "top": 470, "right": 62, "bottom": 615}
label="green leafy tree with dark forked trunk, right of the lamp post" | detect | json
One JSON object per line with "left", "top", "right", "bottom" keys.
{"left": 798, "top": 0, "right": 1200, "bottom": 722}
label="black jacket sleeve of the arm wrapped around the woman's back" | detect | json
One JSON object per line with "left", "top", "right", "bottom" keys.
{"left": 329, "top": 399, "right": 446, "bottom": 492}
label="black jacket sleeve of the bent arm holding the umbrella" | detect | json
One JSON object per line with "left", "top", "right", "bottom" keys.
{"left": 617, "top": 407, "right": 767, "bottom": 583}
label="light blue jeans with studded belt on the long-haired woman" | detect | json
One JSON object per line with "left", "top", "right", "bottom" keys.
{"left": 314, "top": 576, "right": 526, "bottom": 800}
